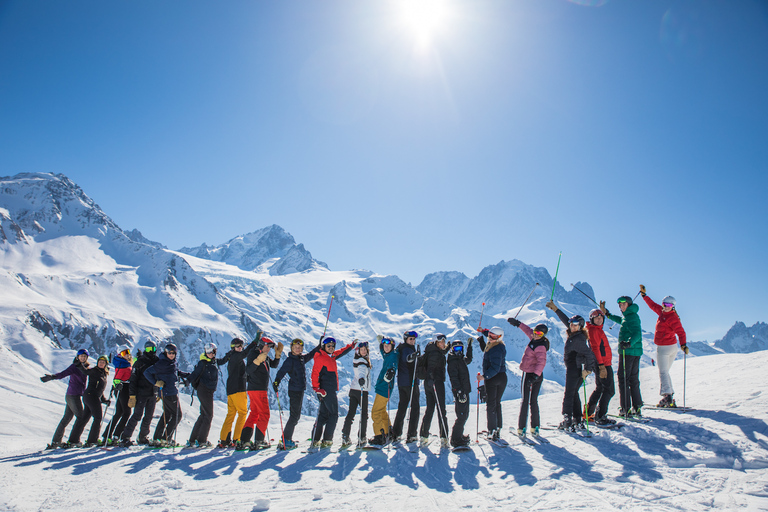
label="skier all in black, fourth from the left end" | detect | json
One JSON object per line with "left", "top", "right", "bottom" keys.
{"left": 120, "top": 340, "right": 158, "bottom": 446}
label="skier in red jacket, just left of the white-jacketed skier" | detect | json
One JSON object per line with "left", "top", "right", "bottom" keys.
{"left": 312, "top": 338, "right": 355, "bottom": 448}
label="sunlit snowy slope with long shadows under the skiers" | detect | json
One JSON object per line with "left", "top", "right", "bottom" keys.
{"left": 0, "top": 352, "right": 768, "bottom": 512}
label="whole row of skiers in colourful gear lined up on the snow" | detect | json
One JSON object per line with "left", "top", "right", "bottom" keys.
{"left": 41, "top": 285, "right": 688, "bottom": 449}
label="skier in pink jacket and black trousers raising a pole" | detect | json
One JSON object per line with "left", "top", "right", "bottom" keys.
{"left": 507, "top": 318, "right": 549, "bottom": 436}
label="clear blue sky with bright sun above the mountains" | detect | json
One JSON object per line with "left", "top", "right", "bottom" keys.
{"left": 0, "top": 0, "right": 768, "bottom": 340}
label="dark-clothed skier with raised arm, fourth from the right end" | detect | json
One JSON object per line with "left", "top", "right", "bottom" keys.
{"left": 547, "top": 301, "right": 597, "bottom": 431}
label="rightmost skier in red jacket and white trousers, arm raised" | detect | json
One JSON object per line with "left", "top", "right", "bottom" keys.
{"left": 640, "top": 284, "right": 688, "bottom": 407}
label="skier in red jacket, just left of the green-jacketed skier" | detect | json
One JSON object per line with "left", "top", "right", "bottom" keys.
{"left": 587, "top": 309, "right": 616, "bottom": 425}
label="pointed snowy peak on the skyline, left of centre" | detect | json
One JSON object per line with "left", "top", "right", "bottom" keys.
{"left": 179, "top": 224, "right": 328, "bottom": 275}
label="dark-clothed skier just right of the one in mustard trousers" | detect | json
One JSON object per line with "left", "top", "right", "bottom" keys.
{"left": 392, "top": 331, "right": 421, "bottom": 443}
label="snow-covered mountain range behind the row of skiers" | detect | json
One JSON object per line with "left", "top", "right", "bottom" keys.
{"left": 0, "top": 173, "right": 768, "bottom": 409}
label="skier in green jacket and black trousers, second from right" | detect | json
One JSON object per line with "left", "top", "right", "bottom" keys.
{"left": 600, "top": 295, "right": 643, "bottom": 417}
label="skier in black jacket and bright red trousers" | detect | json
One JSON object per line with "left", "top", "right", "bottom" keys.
{"left": 239, "top": 336, "right": 283, "bottom": 449}
